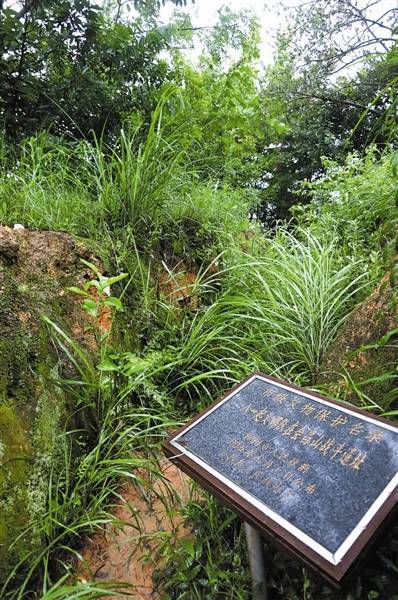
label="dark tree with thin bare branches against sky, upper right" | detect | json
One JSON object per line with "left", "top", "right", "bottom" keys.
{"left": 258, "top": 2, "right": 397, "bottom": 222}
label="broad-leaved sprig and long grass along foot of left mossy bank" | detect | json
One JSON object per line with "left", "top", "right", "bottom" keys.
{"left": 0, "top": 265, "right": 177, "bottom": 600}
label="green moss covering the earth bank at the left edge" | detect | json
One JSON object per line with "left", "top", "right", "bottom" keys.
{"left": 0, "top": 268, "right": 70, "bottom": 579}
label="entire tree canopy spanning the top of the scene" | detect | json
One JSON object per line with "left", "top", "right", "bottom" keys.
{"left": 0, "top": 0, "right": 398, "bottom": 223}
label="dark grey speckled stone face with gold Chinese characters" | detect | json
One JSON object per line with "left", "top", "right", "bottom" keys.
{"left": 177, "top": 377, "right": 398, "bottom": 554}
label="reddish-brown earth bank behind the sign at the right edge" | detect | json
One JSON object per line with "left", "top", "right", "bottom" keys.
{"left": 318, "top": 275, "right": 398, "bottom": 409}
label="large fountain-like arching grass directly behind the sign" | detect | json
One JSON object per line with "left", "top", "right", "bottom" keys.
{"left": 119, "top": 231, "right": 369, "bottom": 413}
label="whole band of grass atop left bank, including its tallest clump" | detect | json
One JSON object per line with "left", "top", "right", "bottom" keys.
{"left": 0, "top": 88, "right": 255, "bottom": 263}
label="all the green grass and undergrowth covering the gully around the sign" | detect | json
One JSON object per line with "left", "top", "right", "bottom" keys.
{"left": 0, "top": 90, "right": 397, "bottom": 600}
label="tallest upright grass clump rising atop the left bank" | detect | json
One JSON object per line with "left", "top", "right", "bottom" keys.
{"left": 92, "top": 88, "right": 188, "bottom": 239}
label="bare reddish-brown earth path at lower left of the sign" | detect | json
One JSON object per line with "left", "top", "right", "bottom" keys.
{"left": 78, "top": 459, "right": 191, "bottom": 600}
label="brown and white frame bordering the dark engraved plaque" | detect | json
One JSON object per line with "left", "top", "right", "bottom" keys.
{"left": 163, "top": 372, "right": 398, "bottom": 586}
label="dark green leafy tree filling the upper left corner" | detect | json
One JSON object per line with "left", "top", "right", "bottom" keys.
{"left": 0, "top": 0, "right": 190, "bottom": 140}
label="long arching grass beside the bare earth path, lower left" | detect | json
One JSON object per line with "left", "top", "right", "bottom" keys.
{"left": 0, "top": 403, "right": 175, "bottom": 600}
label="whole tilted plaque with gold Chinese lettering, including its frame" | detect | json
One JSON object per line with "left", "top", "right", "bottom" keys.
{"left": 164, "top": 374, "right": 398, "bottom": 582}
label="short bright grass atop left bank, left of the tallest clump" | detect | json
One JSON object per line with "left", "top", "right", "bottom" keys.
{"left": 0, "top": 132, "right": 98, "bottom": 236}
